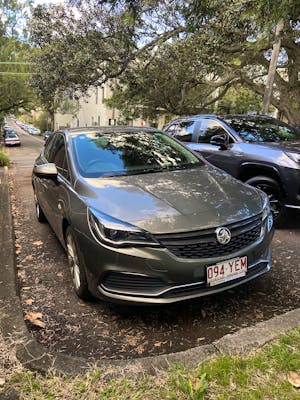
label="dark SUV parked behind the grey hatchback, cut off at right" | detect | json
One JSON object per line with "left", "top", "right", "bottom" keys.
{"left": 164, "top": 114, "right": 300, "bottom": 219}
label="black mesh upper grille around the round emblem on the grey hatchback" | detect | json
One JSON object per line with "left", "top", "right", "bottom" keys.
{"left": 155, "top": 214, "right": 261, "bottom": 258}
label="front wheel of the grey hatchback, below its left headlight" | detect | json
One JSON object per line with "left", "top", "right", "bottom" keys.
{"left": 66, "top": 226, "right": 91, "bottom": 300}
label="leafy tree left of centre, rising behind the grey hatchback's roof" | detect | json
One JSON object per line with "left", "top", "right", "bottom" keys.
{"left": 30, "top": 4, "right": 141, "bottom": 123}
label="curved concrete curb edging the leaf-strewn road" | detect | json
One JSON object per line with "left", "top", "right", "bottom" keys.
{"left": 0, "top": 168, "right": 300, "bottom": 379}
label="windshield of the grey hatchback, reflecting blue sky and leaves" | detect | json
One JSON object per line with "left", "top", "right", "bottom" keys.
{"left": 72, "top": 131, "right": 203, "bottom": 178}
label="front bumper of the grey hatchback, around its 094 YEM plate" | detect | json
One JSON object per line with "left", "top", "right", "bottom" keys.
{"left": 78, "top": 217, "right": 274, "bottom": 304}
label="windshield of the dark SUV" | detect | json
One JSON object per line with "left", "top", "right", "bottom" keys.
{"left": 225, "top": 118, "right": 300, "bottom": 142}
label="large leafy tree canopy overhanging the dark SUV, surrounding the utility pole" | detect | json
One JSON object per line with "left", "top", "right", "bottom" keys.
{"left": 111, "top": 0, "right": 300, "bottom": 123}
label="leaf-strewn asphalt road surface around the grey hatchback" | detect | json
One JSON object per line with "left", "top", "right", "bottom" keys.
{"left": 7, "top": 123, "right": 300, "bottom": 359}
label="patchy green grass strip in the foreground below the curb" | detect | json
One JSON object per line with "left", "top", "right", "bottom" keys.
{"left": 0, "top": 327, "right": 300, "bottom": 400}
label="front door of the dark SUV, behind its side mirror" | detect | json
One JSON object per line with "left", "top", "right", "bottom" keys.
{"left": 187, "top": 119, "right": 242, "bottom": 176}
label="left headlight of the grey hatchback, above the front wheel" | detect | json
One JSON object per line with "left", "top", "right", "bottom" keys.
{"left": 87, "top": 208, "right": 159, "bottom": 247}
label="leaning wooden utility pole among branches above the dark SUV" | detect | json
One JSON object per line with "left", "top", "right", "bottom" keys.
{"left": 262, "top": 19, "right": 284, "bottom": 114}
